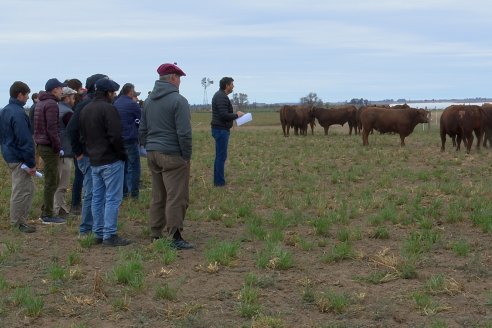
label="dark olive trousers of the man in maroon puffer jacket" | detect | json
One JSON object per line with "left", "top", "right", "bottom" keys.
{"left": 37, "top": 145, "right": 60, "bottom": 216}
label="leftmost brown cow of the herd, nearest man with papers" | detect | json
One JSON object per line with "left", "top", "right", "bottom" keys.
{"left": 280, "top": 105, "right": 314, "bottom": 137}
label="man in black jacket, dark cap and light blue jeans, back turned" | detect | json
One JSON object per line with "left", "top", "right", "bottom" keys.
{"left": 79, "top": 77, "right": 131, "bottom": 246}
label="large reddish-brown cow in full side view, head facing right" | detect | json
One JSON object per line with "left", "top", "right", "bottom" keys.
{"left": 360, "top": 107, "right": 429, "bottom": 146}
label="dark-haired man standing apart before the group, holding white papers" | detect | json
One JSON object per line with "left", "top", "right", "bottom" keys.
{"left": 211, "top": 77, "right": 244, "bottom": 187}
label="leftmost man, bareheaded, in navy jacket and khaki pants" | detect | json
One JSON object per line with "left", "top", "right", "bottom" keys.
{"left": 0, "top": 81, "right": 36, "bottom": 233}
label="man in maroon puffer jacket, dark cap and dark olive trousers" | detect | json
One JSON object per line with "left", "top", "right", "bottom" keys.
{"left": 34, "top": 78, "right": 66, "bottom": 224}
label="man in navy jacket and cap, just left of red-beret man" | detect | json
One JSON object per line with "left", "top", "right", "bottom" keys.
{"left": 113, "top": 83, "right": 142, "bottom": 199}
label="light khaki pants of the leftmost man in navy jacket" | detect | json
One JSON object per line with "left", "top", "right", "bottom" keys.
{"left": 8, "top": 163, "right": 34, "bottom": 225}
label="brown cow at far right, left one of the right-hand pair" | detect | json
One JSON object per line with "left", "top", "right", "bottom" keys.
{"left": 440, "top": 105, "right": 483, "bottom": 154}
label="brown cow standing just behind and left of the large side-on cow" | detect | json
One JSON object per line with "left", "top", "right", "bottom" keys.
{"left": 312, "top": 105, "right": 357, "bottom": 135}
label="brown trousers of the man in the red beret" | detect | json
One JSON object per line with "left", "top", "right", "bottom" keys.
{"left": 147, "top": 151, "right": 190, "bottom": 237}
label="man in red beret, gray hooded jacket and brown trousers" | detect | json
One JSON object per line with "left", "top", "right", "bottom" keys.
{"left": 139, "top": 64, "right": 193, "bottom": 249}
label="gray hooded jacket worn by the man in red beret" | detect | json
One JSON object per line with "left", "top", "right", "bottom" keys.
{"left": 139, "top": 80, "right": 192, "bottom": 161}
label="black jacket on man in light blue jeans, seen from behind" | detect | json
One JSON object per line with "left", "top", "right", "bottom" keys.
{"left": 79, "top": 94, "right": 126, "bottom": 166}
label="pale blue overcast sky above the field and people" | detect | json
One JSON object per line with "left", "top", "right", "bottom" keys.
{"left": 0, "top": 0, "right": 492, "bottom": 104}
